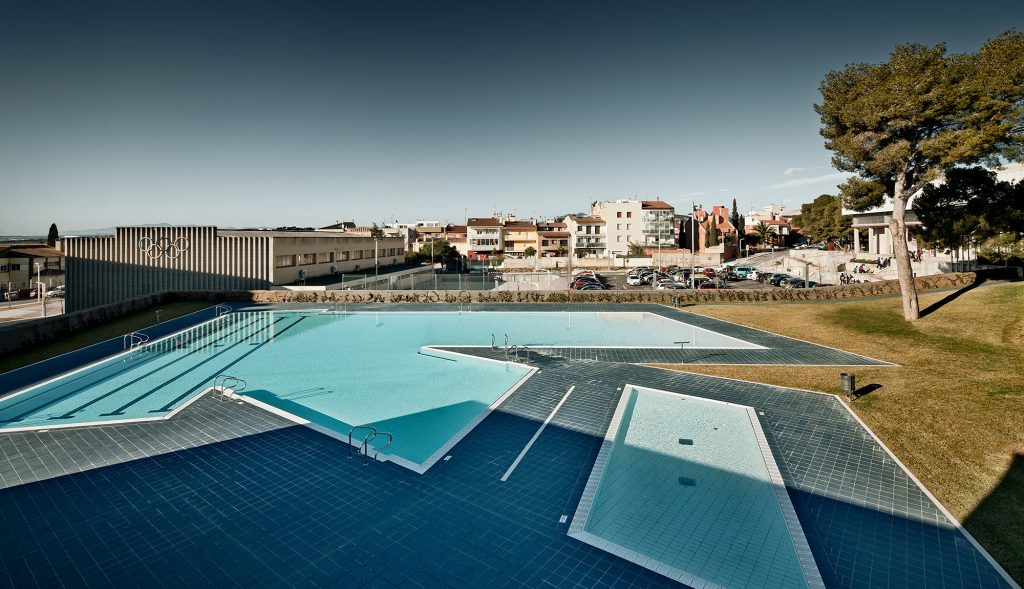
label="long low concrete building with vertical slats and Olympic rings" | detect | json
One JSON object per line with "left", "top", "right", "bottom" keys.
{"left": 60, "top": 226, "right": 406, "bottom": 311}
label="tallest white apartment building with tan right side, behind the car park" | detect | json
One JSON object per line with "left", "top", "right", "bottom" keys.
{"left": 591, "top": 199, "right": 676, "bottom": 255}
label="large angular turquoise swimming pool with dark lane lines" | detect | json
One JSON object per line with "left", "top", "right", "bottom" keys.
{"left": 0, "top": 310, "right": 759, "bottom": 473}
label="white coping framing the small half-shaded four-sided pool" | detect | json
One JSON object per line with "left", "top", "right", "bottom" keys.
{"left": 568, "top": 383, "right": 825, "bottom": 589}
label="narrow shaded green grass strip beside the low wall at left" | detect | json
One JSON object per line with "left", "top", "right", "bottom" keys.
{"left": 0, "top": 301, "right": 213, "bottom": 374}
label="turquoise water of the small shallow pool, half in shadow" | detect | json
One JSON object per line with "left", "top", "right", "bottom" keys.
{"left": 583, "top": 387, "right": 808, "bottom": 588}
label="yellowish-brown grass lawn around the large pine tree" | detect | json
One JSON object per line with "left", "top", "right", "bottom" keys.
{"left": 651, "top": 284, "right": 1024, "bottom": 584}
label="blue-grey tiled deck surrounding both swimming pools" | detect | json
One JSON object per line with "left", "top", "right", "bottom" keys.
{"left": 0, "top": 305, "right": 1014, "bottom": 588}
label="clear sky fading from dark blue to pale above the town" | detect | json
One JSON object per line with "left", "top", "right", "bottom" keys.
{"left": 0, "top": 0, "right": 1024, "bottom": 235}
